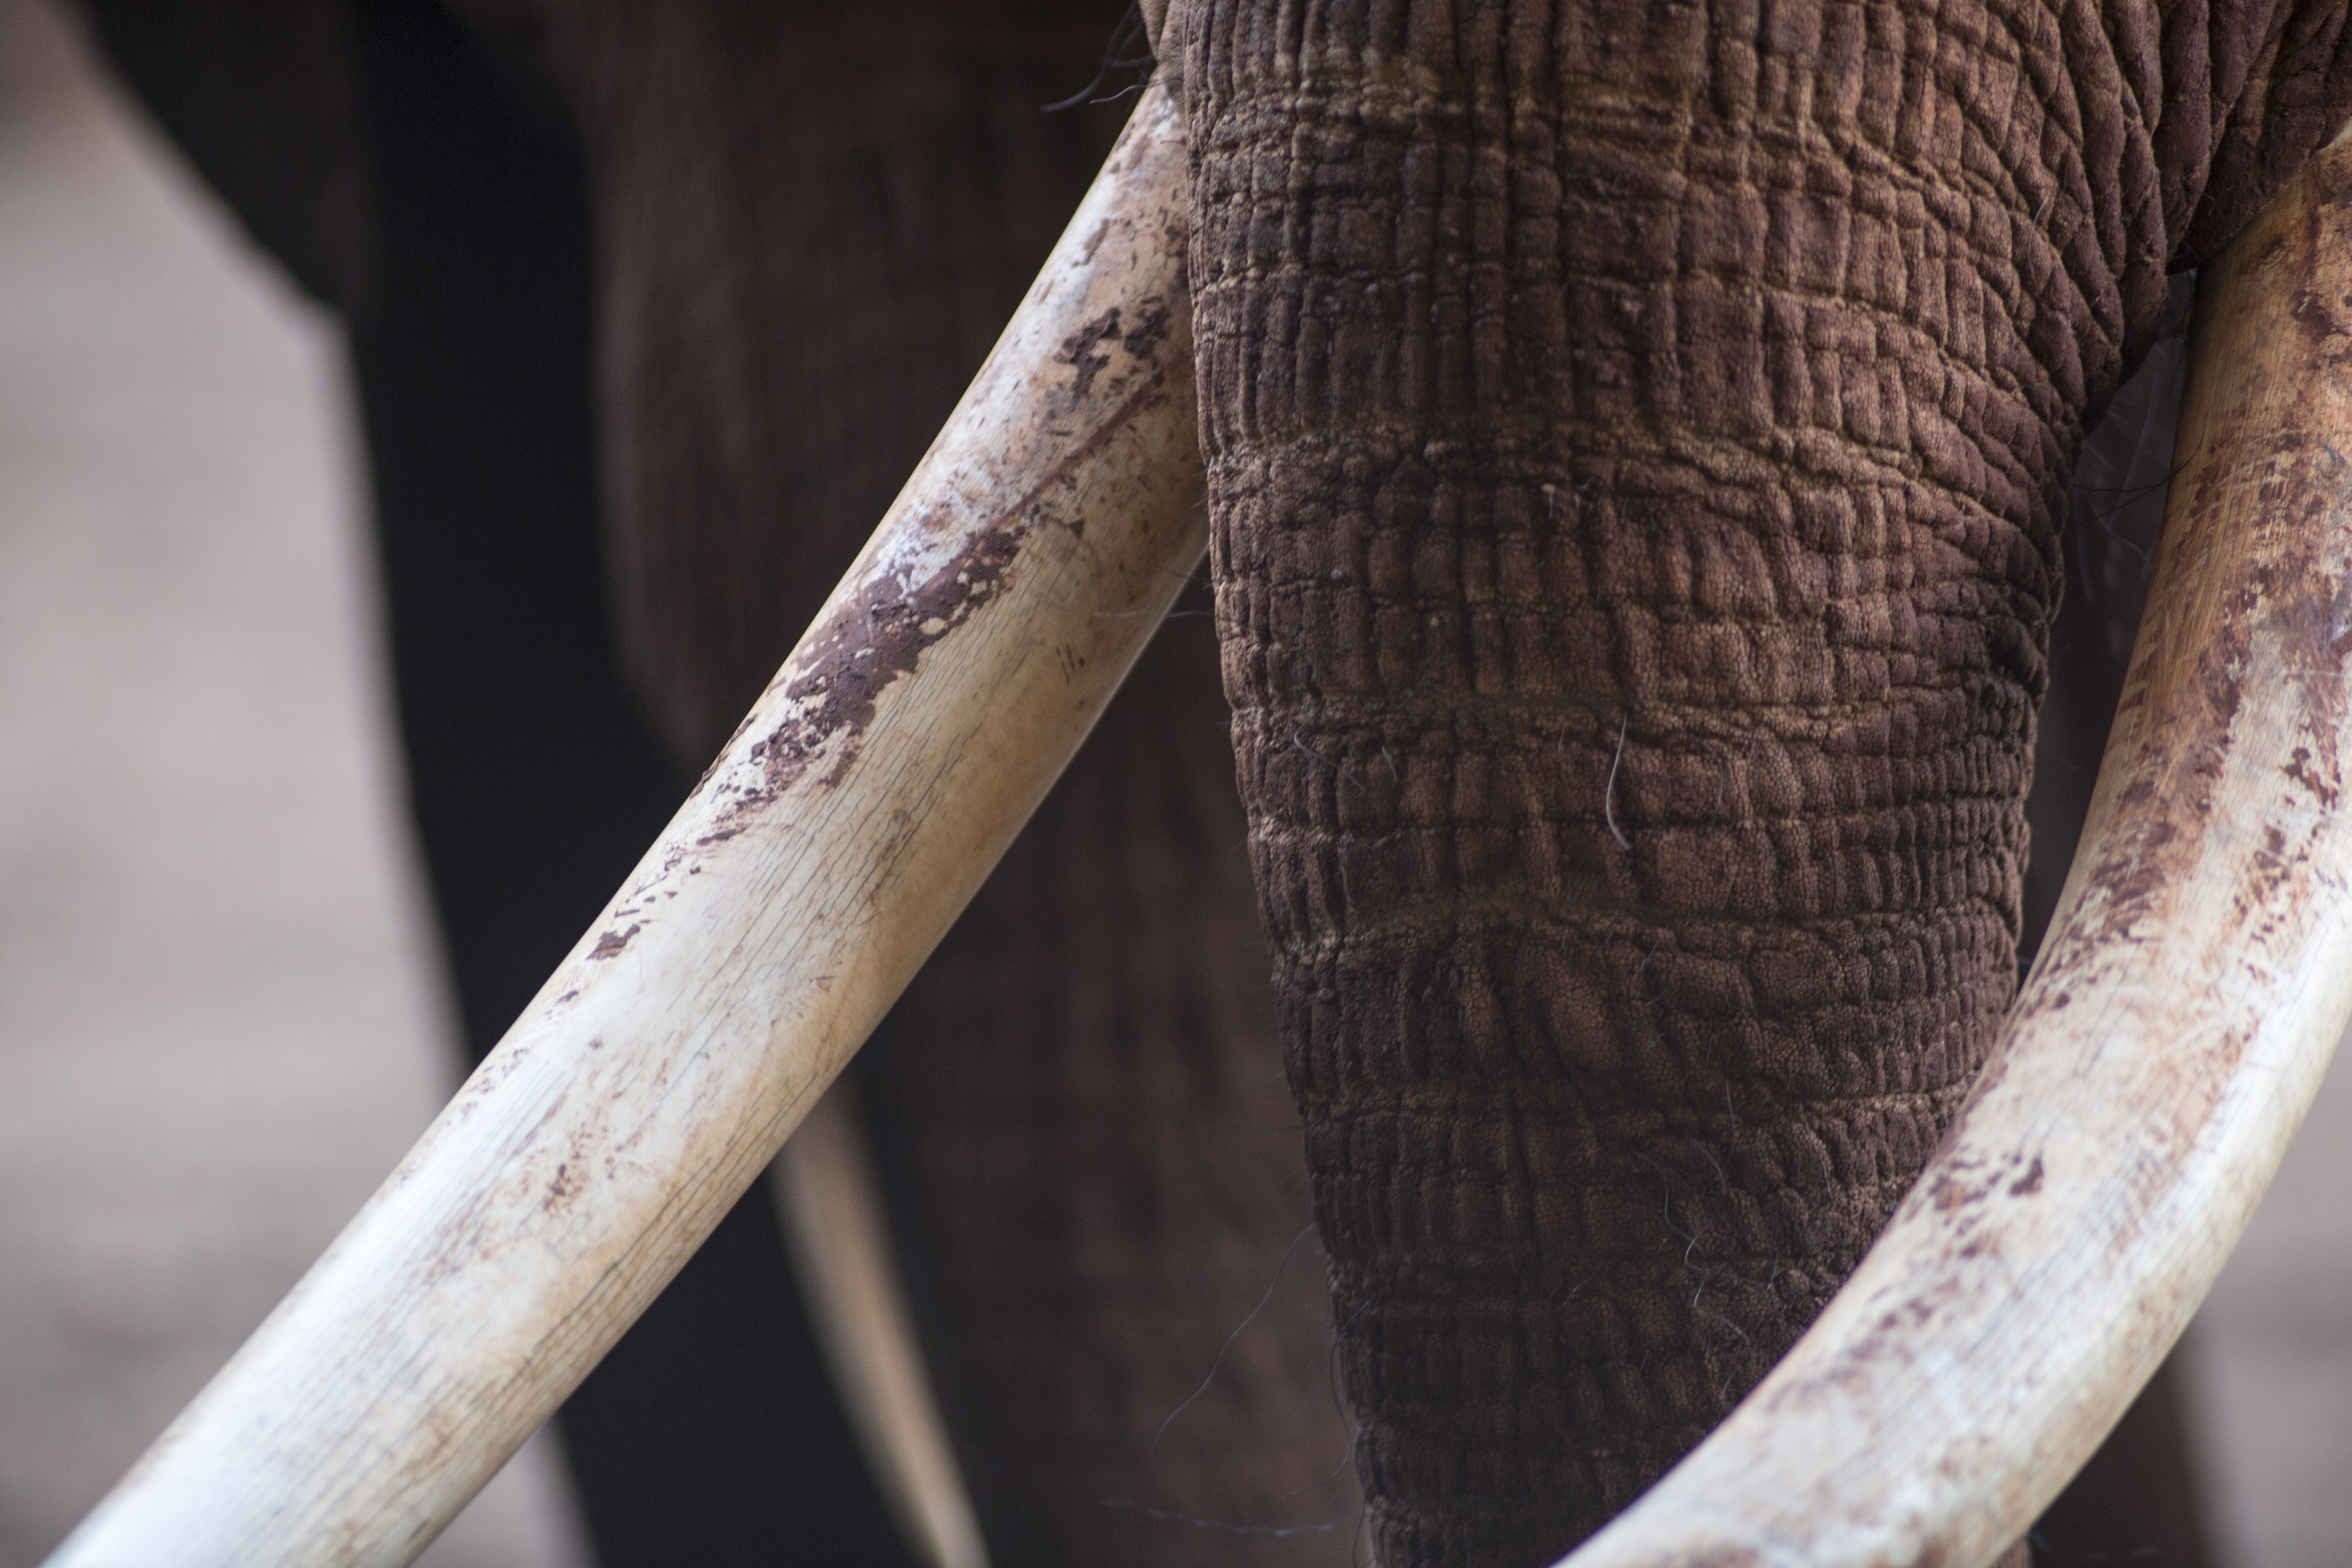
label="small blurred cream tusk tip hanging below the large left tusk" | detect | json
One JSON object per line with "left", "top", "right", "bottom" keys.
{"left": 769, "top": 1079, "right": 988, "bottom": 1568}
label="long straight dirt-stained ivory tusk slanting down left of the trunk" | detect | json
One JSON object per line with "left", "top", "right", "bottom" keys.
{"left": 52, "top": 91, "right": 1206, "bottom": 1568}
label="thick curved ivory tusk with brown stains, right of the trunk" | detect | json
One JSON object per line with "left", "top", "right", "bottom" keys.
{"left": 1569, "top": 136, "right": 2352, "bottom": 1568}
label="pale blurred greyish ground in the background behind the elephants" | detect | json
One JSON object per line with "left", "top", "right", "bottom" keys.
{"left": 0, "top": 0, "right": 2352, "bottom": 1568}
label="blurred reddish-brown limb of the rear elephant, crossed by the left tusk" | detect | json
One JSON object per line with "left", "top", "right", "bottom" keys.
{"left": 526, "top": 0, "right": 1357, "bottom": 1564}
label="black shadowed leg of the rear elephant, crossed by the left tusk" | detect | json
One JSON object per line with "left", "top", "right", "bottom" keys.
{"left": 353, "top": 4, "right": 910, "bottom": 1568}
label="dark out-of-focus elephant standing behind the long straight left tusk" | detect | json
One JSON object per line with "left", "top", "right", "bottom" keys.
{"left": 85, "top": 0, "right": 1357, "bottom": 1568}
